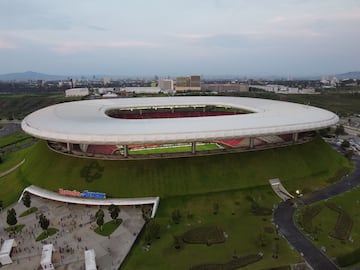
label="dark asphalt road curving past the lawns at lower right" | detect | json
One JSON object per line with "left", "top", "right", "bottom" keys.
{"left": 274, "top": 156, "right": 360, "bottom": 270}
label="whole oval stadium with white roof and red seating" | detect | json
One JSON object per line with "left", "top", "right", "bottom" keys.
{"left": 22, "top": 96, "right": 339, "bottom": 160}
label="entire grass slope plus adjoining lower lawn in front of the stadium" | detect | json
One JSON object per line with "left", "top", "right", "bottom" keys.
{"left": 0, "top": 135, "right": 351, "bottom": 269}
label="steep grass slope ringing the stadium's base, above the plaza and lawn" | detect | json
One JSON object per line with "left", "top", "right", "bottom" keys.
{"left": 0, "top": 138, "right": 351, "bottom": 201}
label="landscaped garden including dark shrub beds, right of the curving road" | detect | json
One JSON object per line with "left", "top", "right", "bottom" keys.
{"left": 296, "top": 189, "right": 360, "bottom": 267}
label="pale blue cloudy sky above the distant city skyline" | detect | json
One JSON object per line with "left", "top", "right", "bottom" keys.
{"left": 0, "top": 0, "right": 360, "bottom": 77}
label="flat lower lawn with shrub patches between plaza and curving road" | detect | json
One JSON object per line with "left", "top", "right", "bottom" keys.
{"left": 122, "top": 187, "right": 301, "bottom": 270}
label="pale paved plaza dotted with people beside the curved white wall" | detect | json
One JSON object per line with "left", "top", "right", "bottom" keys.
{"left": 0, "top": 196, "right": 144, "bottom": 270}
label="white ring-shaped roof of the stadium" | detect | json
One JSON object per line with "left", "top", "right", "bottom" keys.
{"left": 21, "top": 96, "right": 339, "bottom": 145}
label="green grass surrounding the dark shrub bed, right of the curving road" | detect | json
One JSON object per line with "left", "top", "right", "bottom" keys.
{"left": 297, "top": 188, "right": 360, "bottom": 264}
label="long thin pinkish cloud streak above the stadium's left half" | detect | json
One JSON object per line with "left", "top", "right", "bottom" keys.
{"left": 52, "top": 41, "right": 160, "bottom": 54}
